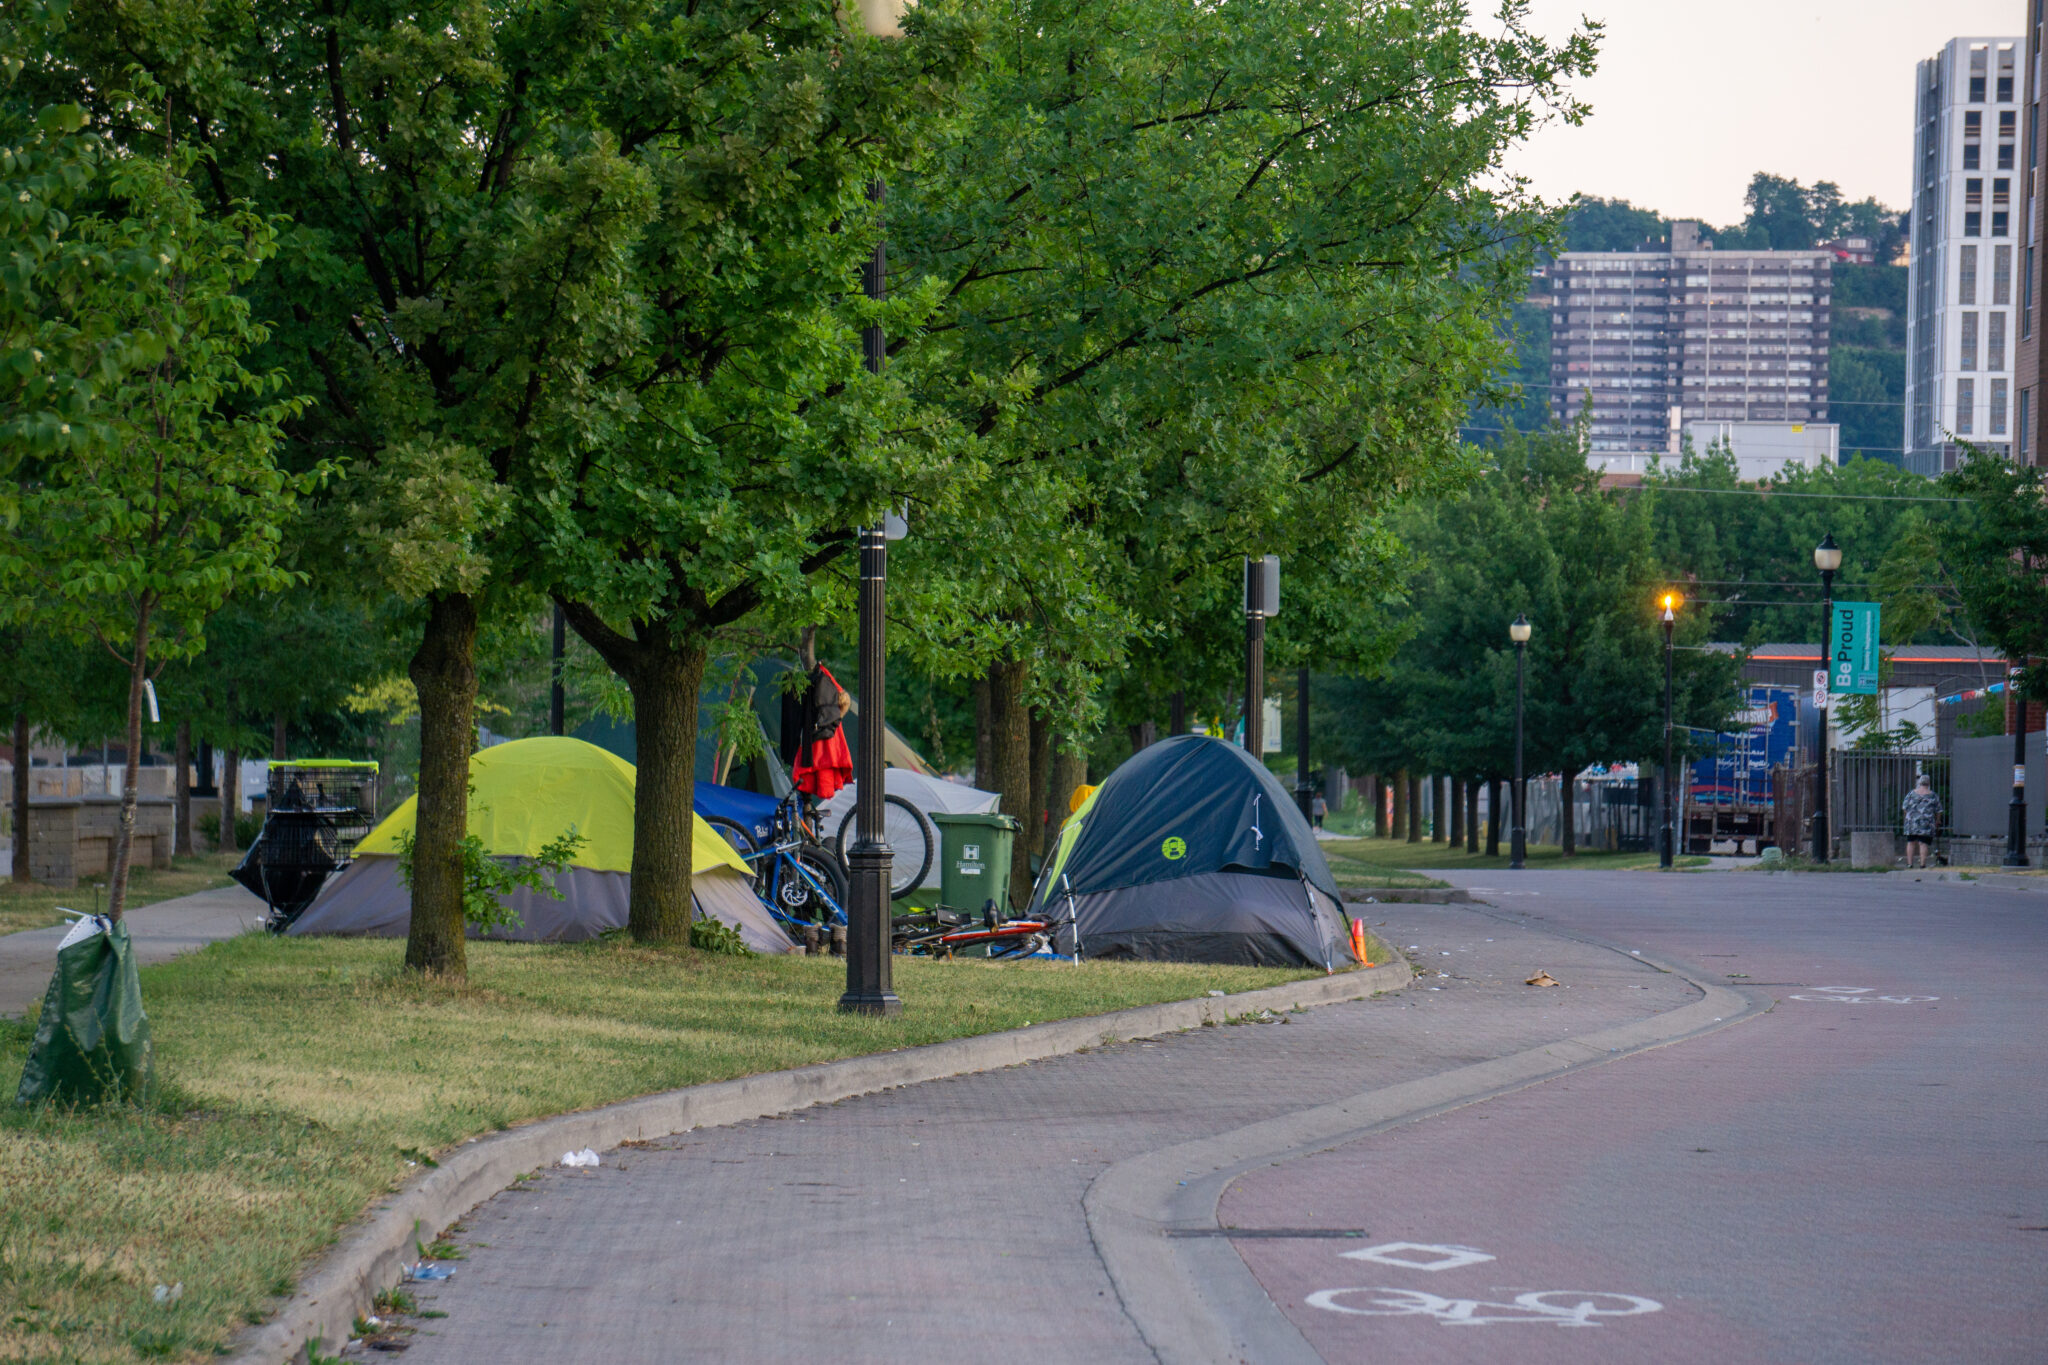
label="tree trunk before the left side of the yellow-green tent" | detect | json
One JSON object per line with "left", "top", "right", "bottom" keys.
{"left": 403, "top": 593, "right": 477, "bottom": 978}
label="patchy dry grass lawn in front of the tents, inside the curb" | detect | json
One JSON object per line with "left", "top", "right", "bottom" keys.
{"left": 0, "top": 935, "right": 1378, "bottom": 1361}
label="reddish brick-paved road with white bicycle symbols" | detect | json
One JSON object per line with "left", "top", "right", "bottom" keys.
{"left": 1219, "top": 872, "right": 2048, "bottom": 1365}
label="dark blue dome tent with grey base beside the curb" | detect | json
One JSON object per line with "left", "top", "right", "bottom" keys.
{"left": 1032, "top": 735, "right": 1350, "bottom": 970}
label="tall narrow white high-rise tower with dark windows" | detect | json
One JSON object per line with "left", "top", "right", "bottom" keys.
{"left": 1905, "top": 37, "right": 2025, "bottom": 475}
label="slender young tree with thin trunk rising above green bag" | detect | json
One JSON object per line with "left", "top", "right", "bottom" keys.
{"left": 0, "top": 156, "right": 305, "bottom": 919}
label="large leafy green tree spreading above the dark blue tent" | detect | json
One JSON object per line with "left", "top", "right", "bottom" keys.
{"left": 897, "top": 0, "right": 1591, "bottom": 888}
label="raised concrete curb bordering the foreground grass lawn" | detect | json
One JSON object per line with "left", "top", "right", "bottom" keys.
{"left": 227, "top": 958, "right": 1415, "bottom": 1365}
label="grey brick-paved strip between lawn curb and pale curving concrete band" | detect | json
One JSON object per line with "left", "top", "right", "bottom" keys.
{"left": 358, "top": 905, "right": 1700, "bottom": 1365}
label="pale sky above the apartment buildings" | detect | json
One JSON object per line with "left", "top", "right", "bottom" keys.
{"left": 1515, "top": 0, "right": 2028, "bottom": 225}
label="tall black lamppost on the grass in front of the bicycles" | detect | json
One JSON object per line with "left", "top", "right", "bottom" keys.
{"left": 840, "top": 180, "right": 903, "bottom": 1015}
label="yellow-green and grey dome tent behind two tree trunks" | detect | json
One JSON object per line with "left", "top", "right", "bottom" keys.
{"left": 289, "top": 735, "right": 791, "bottom": 952}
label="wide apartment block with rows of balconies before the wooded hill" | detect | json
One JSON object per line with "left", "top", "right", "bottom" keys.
{"left": 1550, "top": 223, "right": 1835, "bottom": 454}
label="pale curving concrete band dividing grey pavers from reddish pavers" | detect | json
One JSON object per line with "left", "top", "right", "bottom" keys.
{"left": 1081, "top": 950, "right": 1772, "bottom": 1365}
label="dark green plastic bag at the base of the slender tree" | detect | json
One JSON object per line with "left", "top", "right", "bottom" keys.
{"left": 14, "top": 919, "right": 150, "bottom": 1105}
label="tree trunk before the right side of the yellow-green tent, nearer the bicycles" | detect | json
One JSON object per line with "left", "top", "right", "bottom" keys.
{"left": 625, "top": 641, "right": 711, "bottom": 948}
